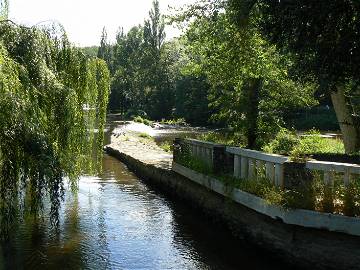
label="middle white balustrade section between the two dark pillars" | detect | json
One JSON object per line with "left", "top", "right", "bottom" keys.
{"left": 226, "top": 147, "right": 289, "bottom": 187}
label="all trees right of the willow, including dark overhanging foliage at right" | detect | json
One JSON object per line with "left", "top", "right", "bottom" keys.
{"left": 99, "top": 0, "right": 360, "bottom": 153}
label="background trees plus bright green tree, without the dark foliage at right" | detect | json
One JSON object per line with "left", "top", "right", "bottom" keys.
{"left": 98, "top": 1, "right": 315, "bottom": 148}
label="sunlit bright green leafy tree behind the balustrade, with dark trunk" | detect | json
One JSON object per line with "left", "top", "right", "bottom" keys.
{"left": 181, "top": 8, "right": 312, "bottom": 148}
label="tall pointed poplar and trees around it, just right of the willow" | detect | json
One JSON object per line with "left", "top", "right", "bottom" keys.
{"left": 107, "top": 1, "right": 181, "bottom": 120}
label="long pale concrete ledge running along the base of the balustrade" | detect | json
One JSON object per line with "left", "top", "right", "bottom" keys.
{"left": 172, "top": 162, "right": 360, "bottom": 236}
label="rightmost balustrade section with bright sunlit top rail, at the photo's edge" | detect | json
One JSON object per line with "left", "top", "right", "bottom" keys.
{"left": 306, "top": 160, "right": 360, "bottom": 186}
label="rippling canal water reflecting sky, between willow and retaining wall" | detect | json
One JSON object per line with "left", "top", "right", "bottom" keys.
{"left": 0, "top": 119, "right": 296, "bottom": 270}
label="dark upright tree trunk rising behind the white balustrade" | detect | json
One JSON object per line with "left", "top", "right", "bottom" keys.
{"left": 246, "top": 78, "right": 262, "bottom": 149}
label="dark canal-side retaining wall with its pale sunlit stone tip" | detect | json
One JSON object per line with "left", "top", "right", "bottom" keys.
{"left": 106, "top": 130, "right": 360, "bottom": 269}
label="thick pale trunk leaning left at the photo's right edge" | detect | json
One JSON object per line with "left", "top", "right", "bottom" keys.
{"left": 331, "top": 87, "right": 360, "bottom": 154}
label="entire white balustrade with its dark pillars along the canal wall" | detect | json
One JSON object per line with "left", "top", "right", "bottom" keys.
{"left": 174, "top": 139, "right": 360, "bottom": 187}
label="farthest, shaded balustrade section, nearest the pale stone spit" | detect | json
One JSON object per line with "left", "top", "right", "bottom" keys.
{"left": 184, "top": 139, "right": 222, "bottom": 166}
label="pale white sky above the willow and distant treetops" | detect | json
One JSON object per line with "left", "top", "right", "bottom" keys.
{"left": 9, "top": 0, "right": 194, "bottom": 47}
